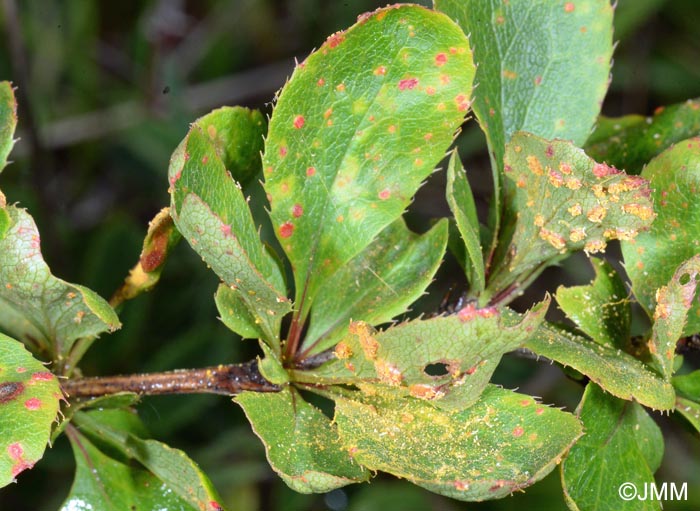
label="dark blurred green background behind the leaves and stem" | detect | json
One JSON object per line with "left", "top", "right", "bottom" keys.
{"left": 0, "top": 0, "right": 700, "bottom": 511}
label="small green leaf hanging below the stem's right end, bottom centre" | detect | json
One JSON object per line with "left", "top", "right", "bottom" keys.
{"left": 235, "top": 387, "right": 369, "bottom": 493}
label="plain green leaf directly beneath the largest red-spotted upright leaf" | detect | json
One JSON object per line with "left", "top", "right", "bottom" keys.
{"left": 303, "top": 218, "right": 447, "bottom": 353}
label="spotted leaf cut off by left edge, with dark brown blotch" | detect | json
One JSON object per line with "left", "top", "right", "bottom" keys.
{"left": 0, "top": 334, "right": 62, "bottom": 487}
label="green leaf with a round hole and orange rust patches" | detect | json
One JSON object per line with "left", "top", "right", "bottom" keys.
{"left": 295, "top": 300, "right": 549, "bottom": 410}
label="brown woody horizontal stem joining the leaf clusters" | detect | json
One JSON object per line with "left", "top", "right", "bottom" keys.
{"left": 61, "top": 360, "right": 280, "bottom": 398}
